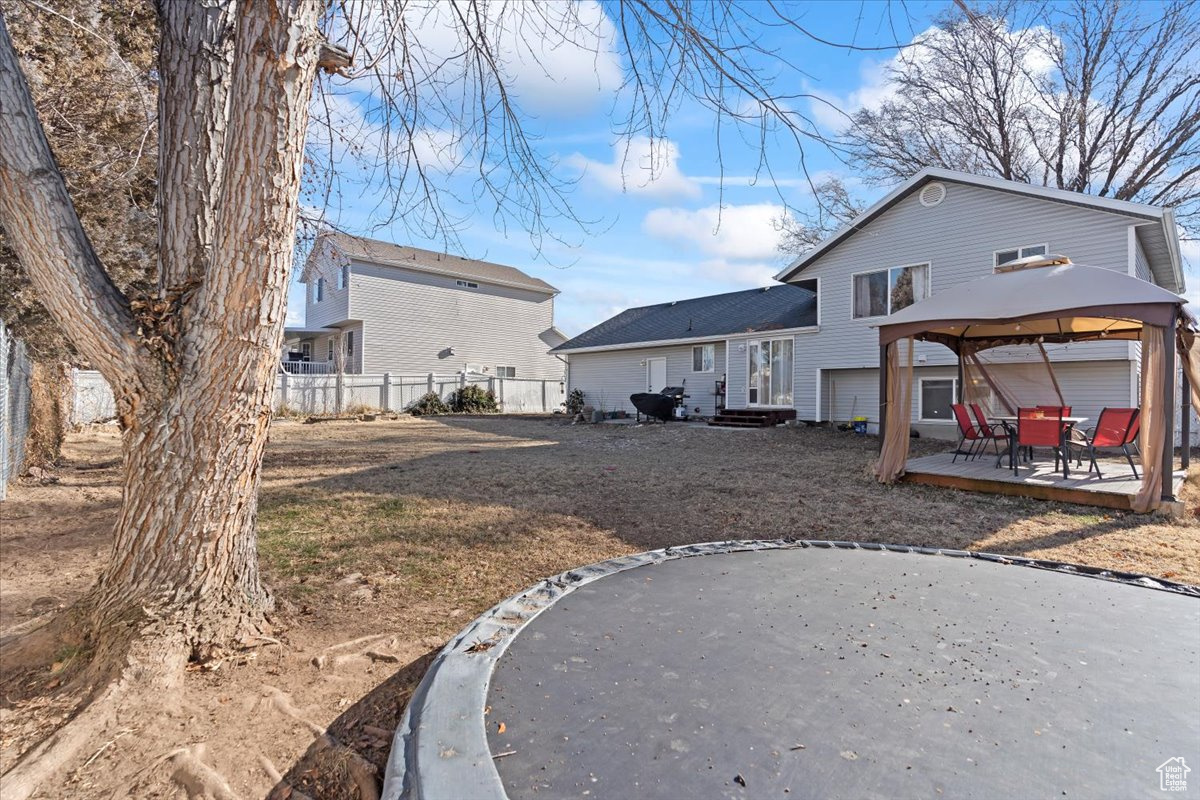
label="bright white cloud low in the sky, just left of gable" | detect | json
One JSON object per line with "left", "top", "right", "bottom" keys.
{"left": 642, "top": 203, "right": 787, "bottom": 261}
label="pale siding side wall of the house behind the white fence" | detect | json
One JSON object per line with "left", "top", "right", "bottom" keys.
{"left": 349, "top": 261, "right": 564, "bottom": 379}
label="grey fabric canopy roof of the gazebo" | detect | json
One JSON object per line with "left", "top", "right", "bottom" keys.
{"left": 880, "top": 255, "right": 1186, "bottom": 353}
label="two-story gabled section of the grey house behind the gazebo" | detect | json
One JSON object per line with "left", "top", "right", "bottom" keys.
{"left": 772, "top": 169, "right": 1184, "bottom": 437}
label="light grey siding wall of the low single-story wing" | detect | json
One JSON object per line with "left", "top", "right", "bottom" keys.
{"left": 568, "top": 341, "right": 725, "bottom": 416}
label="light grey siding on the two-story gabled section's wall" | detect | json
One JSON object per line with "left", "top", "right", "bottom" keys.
{"left": 772, "top": 178, "right": 1148, "bottom": 420}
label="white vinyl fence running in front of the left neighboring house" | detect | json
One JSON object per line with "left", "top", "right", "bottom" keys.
{"left": 275, "top": 372, "right": 566, "bottom": 414}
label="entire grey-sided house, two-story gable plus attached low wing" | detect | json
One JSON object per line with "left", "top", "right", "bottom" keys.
{"left": 557, "top": 169, "right": 1184, "bottom": 437}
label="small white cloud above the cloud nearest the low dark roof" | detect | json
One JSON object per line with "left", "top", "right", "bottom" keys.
{"left": 564, "top": 136, "right": 702, "bottom": 200}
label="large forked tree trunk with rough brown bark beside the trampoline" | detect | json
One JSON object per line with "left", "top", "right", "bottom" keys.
{"left": 0, "top": 0, "right": 322, "bottom": 658}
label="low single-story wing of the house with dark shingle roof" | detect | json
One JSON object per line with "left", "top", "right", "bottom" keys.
{"left": 552, "top": 284, "right": 817, "bottom": 416}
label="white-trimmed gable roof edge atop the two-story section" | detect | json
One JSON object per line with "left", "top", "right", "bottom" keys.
{"left": 775, "top": 167, "right": 1184, "bottom": 294}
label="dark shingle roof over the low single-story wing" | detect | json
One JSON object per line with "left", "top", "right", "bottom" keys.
{"left": 551, "top": 283, "right": 817, "bottom": 353}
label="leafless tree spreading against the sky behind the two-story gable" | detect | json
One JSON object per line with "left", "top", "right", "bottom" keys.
{"left": 846, "top": 0, "right": 1200, "bottom": 227}
